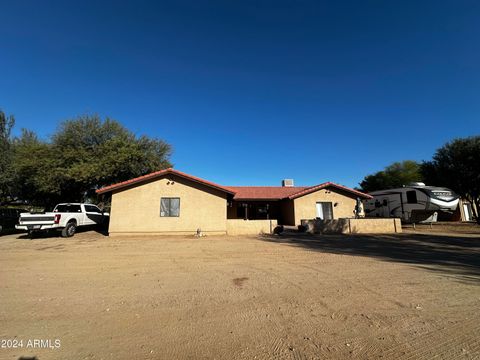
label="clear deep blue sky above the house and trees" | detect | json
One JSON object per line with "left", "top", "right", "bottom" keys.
{"left": 0, "top": 1, "right": 480, "bottom": 186}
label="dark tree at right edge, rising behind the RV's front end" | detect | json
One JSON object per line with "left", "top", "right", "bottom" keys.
{"left": 421, "top": 136, "right": 480, "bottom": 219}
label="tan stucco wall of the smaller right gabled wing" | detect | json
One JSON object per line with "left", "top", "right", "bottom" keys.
{"left": 293, "top": 189, "right": 356, "bottom": 225}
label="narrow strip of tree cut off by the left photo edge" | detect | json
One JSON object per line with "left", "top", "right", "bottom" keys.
{"left": 0, "top": 110, "right": 15, "bottom": 203}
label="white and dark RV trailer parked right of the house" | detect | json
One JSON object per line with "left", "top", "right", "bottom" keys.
{"left": 365, "top": 183, "right": 460, "bottom": 222}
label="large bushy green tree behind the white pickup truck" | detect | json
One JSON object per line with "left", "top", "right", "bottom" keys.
{"left": 11, "top": 115, "right": 171, "bottom": 205}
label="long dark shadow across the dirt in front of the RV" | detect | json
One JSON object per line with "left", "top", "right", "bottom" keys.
{"left": 260, "top": 233, "right": 480, "bottom": 284}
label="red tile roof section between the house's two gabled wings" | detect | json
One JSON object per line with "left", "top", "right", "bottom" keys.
{"left": 227, "top": 186, "right": 308, "bottom": 200}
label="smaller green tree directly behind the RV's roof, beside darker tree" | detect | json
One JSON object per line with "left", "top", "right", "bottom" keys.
{"left": 360, "top": 160, "right": 422, "bottom": 192}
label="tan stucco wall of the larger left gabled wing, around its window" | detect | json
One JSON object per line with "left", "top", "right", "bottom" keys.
{"left": 109, "top": 175, "right": 227, "bottom": 234}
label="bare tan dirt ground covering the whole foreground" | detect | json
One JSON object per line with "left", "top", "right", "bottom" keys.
{"left": 0, "top": 232, "right": 480, "bottom": 360}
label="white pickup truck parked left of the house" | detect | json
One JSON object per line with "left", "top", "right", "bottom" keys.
{"left": 15, "top": 203, "right": 109, "bottom": 237}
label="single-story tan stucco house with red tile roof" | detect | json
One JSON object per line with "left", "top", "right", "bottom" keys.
{"left": 97, "top": 169, "right": 370, "bottom": 235}
